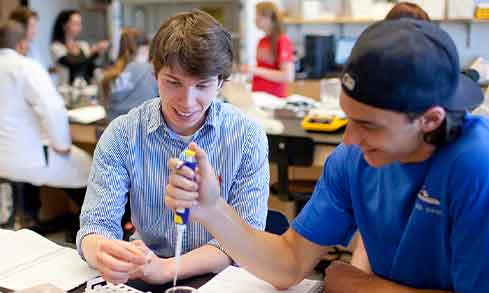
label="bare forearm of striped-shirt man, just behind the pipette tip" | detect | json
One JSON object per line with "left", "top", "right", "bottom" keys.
{"left": 167, "top": 245, "right": 231, "bottom": 279}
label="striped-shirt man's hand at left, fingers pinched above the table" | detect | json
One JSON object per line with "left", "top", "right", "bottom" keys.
{"left": 87, "top": 236, "right": 145, "bottom": 284}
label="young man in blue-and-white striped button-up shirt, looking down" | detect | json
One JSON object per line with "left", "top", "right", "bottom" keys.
{"left": 77, "top": 10, "right": 269, "bottom": 283}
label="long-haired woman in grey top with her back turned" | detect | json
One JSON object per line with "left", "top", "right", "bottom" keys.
{"left": 101, "top": 27, "right": 158, "bottom": 121}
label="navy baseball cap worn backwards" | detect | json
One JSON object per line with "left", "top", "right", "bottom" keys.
{"left": 342, "top": 18, "right": 484, "bottom": 113}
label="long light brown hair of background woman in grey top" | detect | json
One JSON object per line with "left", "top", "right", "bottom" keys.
{"left": 101, "top": 27, "right": 149, "bottom": 103}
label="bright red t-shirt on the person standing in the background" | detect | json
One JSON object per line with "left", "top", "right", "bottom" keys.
{"left": 251, "top": 35, "right": 294, "bottom": 97}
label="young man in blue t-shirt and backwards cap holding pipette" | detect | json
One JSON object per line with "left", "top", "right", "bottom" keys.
{"left": 166, "top": 19, "right": 489, "bottom": 293}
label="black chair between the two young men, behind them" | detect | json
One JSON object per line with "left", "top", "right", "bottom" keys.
{"left": 268, "top": 135, "right": 316, "bottom": 213}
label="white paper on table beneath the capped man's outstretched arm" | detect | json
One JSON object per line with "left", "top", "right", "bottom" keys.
{"left": 199, "top": 266, "right": 324, "bottom": 293}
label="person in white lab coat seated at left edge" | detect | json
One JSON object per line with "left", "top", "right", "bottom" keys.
{"left": 0, "top": 21, "right": 91, "bottom": 228}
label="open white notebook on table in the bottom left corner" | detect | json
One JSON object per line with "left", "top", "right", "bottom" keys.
{"left": 0, "top": 229, "right": 98, "bottom": 291}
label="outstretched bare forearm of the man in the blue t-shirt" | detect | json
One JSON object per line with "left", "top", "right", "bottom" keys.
{"left": 198, "top": 199, "right": 303, "bottom": 288}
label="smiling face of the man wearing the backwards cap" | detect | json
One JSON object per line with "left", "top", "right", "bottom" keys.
{"left": 340, "top": 92, "right": 434, "bottom": 167}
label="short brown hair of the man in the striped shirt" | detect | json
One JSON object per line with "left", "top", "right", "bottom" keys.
{"left": 149, "top": 9, "right": 233, "bottom": 80}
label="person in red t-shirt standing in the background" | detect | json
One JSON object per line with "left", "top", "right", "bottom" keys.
{"left": 248, "top": 2, "right": 294, "bottom": 97}
